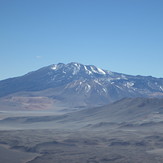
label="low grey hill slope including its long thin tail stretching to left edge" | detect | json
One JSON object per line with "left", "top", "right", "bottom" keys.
{"left": 0, "top": 98, "right": 163, "bottom": 128}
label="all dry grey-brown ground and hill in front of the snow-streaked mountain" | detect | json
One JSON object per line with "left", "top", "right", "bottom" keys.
{"left": 0, "top": 99, "right": 163, "bottom": 163}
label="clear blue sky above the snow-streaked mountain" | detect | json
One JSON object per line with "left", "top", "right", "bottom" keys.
{"left": 0, "top": 0, "right": 163, "bottom": 80}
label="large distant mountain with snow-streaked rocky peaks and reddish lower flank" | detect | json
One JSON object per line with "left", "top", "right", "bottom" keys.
{"left": 0, "top": 62, "right": 163, "bottom": 110}
